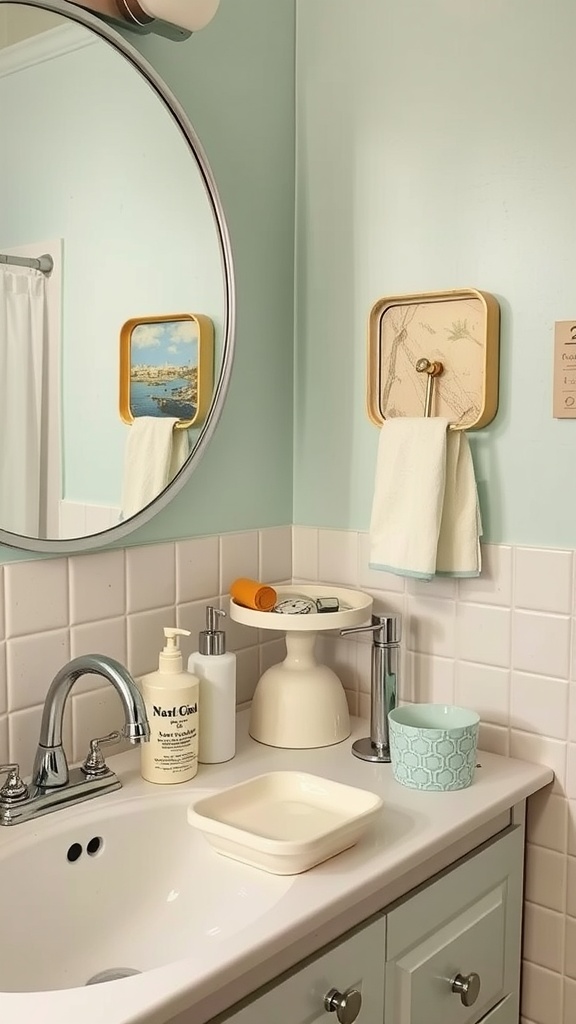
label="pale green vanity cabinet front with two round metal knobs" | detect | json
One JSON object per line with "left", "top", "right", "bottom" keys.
{"left": 214, "top": 825, "right": 524, "bottom": 1024}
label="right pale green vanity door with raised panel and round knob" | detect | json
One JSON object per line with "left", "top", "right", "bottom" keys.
{"left": 386, "top": 828, "right": 523, "bottom": 1024}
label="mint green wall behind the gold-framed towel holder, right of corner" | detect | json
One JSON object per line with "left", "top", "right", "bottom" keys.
{"left": 294, "top": 0, "right": 576, "bottom": 547}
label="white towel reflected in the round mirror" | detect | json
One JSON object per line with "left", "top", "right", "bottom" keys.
{"left": 122, "top": 416, "right": 190, "bottom": 519}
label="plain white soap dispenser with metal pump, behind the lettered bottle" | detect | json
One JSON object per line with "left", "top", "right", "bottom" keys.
{"left": 188, "top": 605, "right": 236, "bottom": 765}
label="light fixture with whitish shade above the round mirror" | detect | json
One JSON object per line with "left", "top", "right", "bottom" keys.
{"left": 69, "top": 0, "right": 220, "bottom": 32}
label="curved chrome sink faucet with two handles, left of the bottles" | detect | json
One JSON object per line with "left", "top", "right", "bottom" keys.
{"left": 0, "top": 654, "right": 150, "bottom": 825}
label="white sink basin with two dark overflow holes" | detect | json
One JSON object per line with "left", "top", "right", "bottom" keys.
{"left": 0, "top": 790, "right": 293, "bottom": 992}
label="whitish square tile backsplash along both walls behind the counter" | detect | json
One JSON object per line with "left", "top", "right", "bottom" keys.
{"left": 0, "top": 526, "right": 576, "bottom": 1024}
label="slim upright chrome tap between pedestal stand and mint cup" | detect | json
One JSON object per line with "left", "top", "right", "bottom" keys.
{"left": 340, "top": 615, "right": 402, "bottom": 762}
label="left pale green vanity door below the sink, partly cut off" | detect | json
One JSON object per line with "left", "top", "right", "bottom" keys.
{"left": 225, "top": 918, "right": 384, "bottom": 1024}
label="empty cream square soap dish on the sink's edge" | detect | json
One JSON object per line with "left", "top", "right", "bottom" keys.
{"left": 188, "top": 771, "right": 382, "bottom": 874}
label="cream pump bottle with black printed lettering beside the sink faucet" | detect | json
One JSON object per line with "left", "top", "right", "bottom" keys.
{"left": 139, "top": 626, "right": 200, "bottom": 785}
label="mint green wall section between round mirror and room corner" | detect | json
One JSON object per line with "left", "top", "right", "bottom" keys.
{"left": 0, "top": 0, "right": 294, "bottom": 561}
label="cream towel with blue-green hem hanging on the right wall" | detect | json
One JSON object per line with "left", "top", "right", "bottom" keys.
{"left": 370, "top": 417, "right": 482, "bottom": 580}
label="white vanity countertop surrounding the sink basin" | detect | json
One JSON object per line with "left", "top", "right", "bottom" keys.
{"left": 0, "top": 712, "right": 553, "bottom": 1024}
